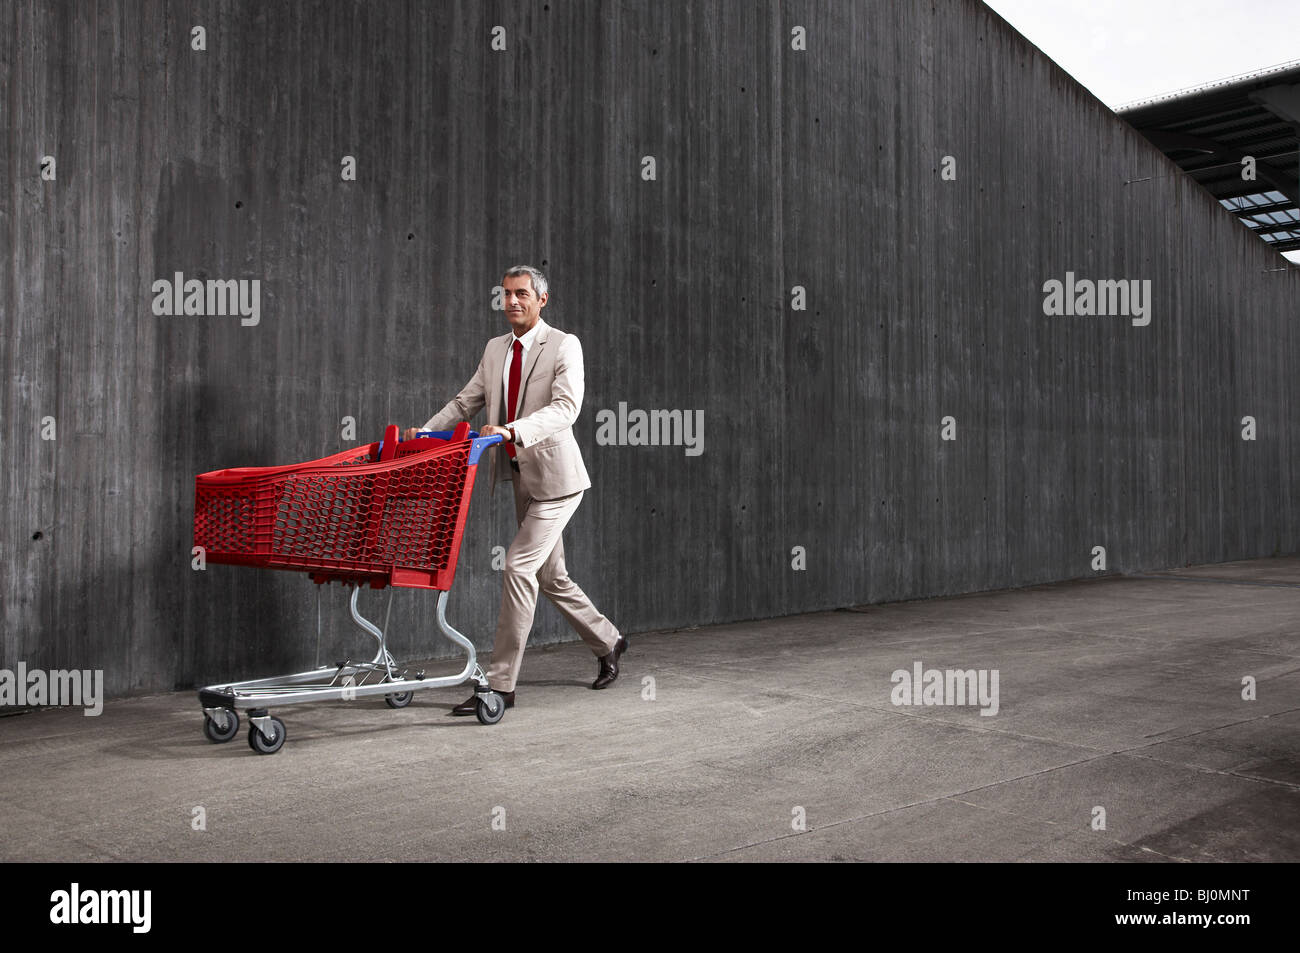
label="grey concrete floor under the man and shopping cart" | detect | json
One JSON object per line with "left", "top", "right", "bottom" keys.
{"left": 0, "top": 558, "right": 1300, "bottom": 861}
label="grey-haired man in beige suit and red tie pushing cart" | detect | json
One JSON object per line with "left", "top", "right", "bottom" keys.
{"left": 406, "top": 265, "right": 628, "bottom": 715}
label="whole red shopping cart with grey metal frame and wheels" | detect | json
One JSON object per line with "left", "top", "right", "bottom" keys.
{"left": 194, "top": 423, "right": 506, "bottom": 754}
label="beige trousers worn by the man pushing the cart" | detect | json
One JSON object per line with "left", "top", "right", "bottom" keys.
{"left": 488, "top": 475, "right": 619, "bottom": 692}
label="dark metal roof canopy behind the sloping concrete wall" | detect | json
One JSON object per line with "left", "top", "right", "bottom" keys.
{"left": 1117, "top": 61, "right": 1300, "bottom": 252}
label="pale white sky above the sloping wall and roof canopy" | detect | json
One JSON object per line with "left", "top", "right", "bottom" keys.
{"left": 984, "top": 0, "right": 1300, "bottom": 109}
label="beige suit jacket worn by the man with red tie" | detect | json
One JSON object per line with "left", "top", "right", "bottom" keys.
{"left": 424, "top": 319, "right": 592, "bottom": 499}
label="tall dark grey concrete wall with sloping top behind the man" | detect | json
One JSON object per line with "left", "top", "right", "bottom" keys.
{"left": 0, "top": 0, "right": 1300, "bottom": 694}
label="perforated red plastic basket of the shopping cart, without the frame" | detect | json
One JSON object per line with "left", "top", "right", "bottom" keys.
{"left": 194, "top": 424, "right": 499, "bottom": 590}
